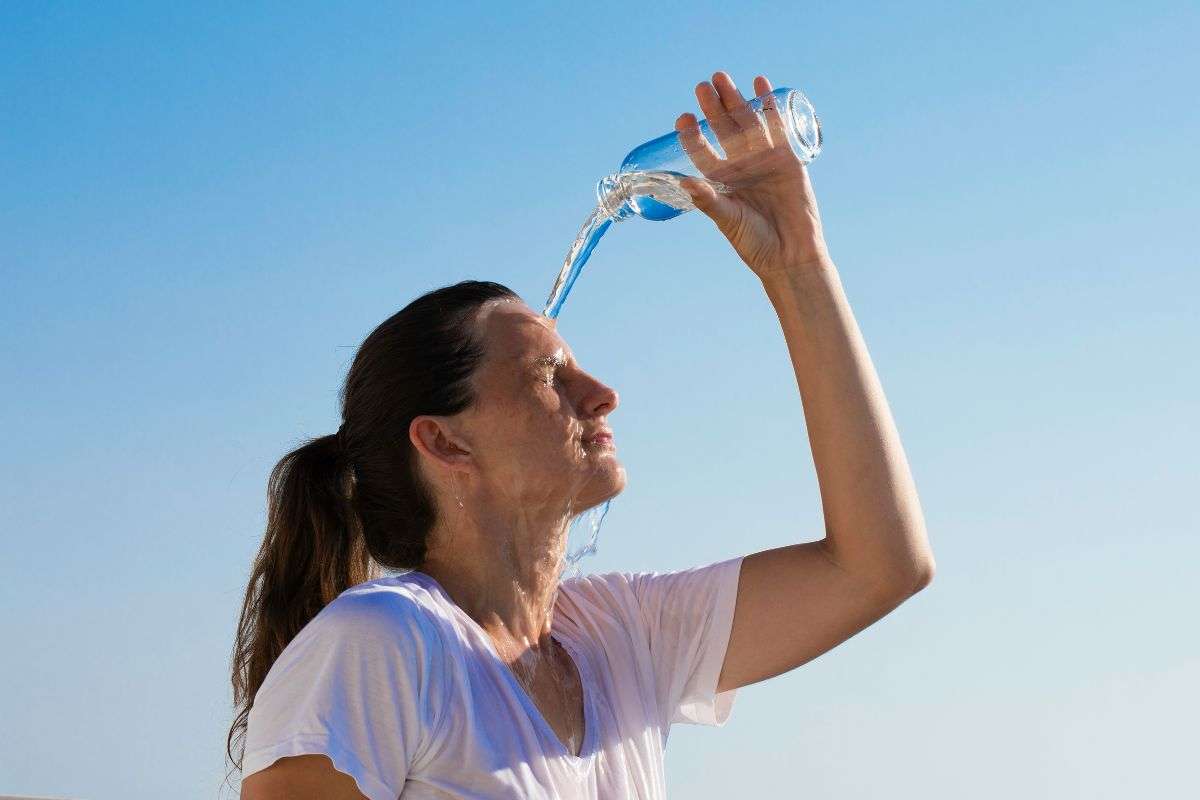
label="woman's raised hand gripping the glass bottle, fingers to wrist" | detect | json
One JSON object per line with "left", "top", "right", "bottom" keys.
{"left": 676, "top": 72, "right": 829, "bottom": 278}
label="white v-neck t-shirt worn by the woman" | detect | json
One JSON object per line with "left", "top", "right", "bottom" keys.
{"left": 242, "top": 557, "right": 743, "bottom": 800}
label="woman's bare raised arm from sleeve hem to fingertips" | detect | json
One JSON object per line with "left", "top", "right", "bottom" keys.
{"left": 676, "top": 72, "right": 934, "bottom": 691}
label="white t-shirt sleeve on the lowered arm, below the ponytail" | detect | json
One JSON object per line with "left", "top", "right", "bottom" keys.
{"left": 242, "top": 589, "right": 440, "bottom": 800}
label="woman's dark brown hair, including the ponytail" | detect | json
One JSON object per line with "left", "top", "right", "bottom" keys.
{"left": 226, "top": 281, "right": 520, "bottom": 770}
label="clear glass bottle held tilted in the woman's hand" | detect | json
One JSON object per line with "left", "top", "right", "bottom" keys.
{"left": 596, "top": 86, "right": 821, "bottom": 222}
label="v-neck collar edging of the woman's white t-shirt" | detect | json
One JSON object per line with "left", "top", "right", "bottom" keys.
{"left": 401, "top": 570, "right": 598, "bottom": 772}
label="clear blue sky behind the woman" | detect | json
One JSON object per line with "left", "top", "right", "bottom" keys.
{"left": 0, "top": 1, "right": 1200, "bottom": 800}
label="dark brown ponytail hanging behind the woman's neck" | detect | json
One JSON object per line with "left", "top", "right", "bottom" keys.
{"left": 226, "top": 434, "right": 371, "bottom": 770}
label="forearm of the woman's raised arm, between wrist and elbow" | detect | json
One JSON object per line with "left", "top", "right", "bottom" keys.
{"left": 762, "top": 259, "right": 934, "bottom": 590}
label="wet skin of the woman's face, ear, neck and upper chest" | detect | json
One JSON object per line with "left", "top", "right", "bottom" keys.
{"left": 410, "top": 301, "right": 626, "bottom": 754}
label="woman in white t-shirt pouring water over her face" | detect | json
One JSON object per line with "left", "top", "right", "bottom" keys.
{"left": 229, "top": 72, "right": 934, "bottom": 800}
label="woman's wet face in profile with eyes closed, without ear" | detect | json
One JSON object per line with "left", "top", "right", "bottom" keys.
{"left": 451, "top": 301, "right": 625, "bottom": 516}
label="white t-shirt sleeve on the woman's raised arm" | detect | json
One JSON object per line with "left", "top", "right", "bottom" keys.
{"left": 629, "top": 555, "right": 743, "bottom": 727}
